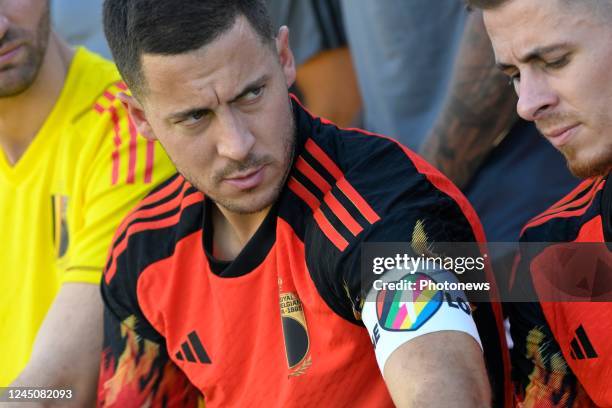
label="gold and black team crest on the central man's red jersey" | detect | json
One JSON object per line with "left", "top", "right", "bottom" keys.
{"left": 279, "top": 292, "right": 312, "bottom": 377}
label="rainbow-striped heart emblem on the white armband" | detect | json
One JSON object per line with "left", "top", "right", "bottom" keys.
{"left": 376, "top": 273, "right": 444, "bottom": 331}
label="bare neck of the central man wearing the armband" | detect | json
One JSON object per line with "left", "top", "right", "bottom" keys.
{"left": 211, "top": 204, "right": 271, "bottom": 261}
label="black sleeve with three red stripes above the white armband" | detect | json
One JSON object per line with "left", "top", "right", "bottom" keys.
{"left": 283, "top": 111, "right": 484, "bottom": 322}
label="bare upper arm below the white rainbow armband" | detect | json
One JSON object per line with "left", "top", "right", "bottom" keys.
{"left": 384, "top": 331, "right": 491, "bottom": 408}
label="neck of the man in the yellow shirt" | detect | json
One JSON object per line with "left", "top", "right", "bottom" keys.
{"left": 0, "top": 32, "right": 74, "bottom": 165}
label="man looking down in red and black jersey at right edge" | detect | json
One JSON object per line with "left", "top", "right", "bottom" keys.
{"left": 469, "top": 0, "right": 612, "bottom": 406}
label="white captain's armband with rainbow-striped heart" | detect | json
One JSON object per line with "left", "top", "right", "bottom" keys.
{"left": 361, "top": 270, "right": 482, "bottom": 372}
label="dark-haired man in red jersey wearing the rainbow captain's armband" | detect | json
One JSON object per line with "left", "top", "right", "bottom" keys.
{"left": 99, "top": 0, "right": 509, "bottom": 407}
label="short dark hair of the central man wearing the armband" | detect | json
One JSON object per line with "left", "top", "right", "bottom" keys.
{"left": 104, "top": 0, "right": 274, "bottom": 93}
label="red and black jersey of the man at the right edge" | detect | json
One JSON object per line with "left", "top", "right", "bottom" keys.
{"left": 509, "top": 177, "right": 612, "bottom": 407}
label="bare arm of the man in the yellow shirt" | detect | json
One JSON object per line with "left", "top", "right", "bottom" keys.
{"left": 11, "top": 283, "right": 103, "bottom": 407}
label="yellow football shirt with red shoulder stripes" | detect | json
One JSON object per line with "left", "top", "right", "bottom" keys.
{"left": 0, "top": 48, "right": 175, "bottom": 387}
